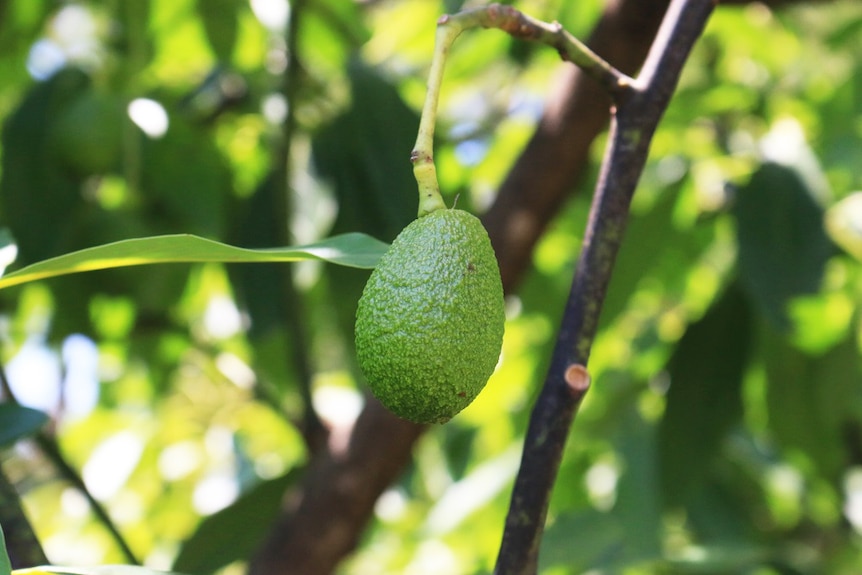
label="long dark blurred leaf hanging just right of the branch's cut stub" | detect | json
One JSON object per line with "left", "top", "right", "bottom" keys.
{"left": 659, "top": 285, "right": 751, "bottom": 505}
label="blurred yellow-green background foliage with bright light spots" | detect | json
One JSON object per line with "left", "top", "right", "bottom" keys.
{"left": 0, "top": 0, "right": 862, "bottom": 575}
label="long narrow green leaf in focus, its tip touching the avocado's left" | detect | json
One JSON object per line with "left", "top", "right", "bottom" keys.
{"left": 0, "top": 233, "right": 387, "bottom": 289}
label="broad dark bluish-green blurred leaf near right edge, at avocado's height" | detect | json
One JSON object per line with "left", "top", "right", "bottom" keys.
{"left": 734, "top": 163, "right": 833, "bottom": 329}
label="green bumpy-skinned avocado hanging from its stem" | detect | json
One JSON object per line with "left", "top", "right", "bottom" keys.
{"left": 356, "top": 209, "right": 505, "bottom": 423}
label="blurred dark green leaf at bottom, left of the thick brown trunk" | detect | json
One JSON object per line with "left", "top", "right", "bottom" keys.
{"left": 173, "top": 470, "right": 300, "bottom": 575}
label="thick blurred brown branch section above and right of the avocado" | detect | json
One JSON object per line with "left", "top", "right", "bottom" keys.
{"left": 483, "top": 0, "right": 680, "bottom": 285}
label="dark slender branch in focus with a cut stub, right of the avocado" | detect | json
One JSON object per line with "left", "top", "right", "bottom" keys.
{"left": 495, "top": 0, "right": 714, "bottom": 575}
